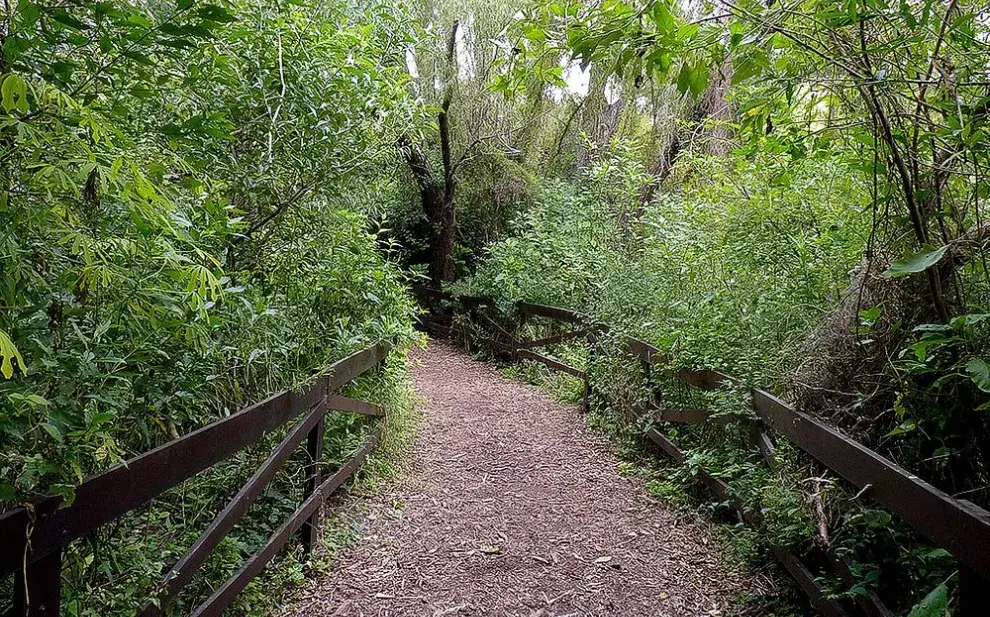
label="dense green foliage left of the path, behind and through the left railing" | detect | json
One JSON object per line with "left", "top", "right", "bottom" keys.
{"left": 0, "top": 0, "right": 423, "bottom": 615}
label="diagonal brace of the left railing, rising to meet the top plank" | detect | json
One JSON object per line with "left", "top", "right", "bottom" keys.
{"left": 141, "top": 398, "right": 328, "bottom": 617}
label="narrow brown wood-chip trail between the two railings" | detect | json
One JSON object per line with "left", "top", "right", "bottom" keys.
{"left": 280, "top": 342, "right": 746, "bottom": 617}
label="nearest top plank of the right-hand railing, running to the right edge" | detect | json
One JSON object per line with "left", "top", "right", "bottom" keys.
{"left": 753, "top": 389, "right": 990, "bottom": 580}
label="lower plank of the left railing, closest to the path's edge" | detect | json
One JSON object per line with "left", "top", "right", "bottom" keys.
{"left": 191, "top": 428, "right": 382, "bottom": 617}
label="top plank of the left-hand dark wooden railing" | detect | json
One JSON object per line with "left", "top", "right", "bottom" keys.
{"left": 0, "top": 345, "right": 386, "bottom": 575}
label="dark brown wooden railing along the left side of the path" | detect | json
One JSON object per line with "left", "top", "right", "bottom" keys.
{"left": 0, "top": 344, "right": 396, "bottom": 617}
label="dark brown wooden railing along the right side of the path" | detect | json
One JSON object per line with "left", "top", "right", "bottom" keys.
{"left": 414, "top": 288, "right": 990, "bottom": 617}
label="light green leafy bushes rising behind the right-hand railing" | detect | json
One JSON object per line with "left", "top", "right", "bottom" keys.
{"left": 472, "top": 143, "right": 868, "bottom": 383}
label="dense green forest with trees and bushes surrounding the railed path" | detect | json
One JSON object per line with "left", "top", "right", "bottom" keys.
{"left": 0, "top": 0, "right": 990, "bottom": 615}
